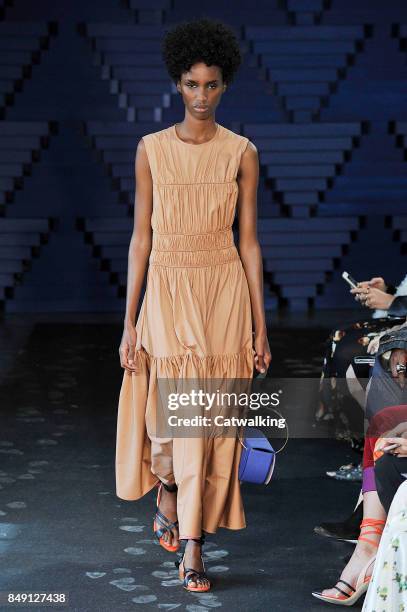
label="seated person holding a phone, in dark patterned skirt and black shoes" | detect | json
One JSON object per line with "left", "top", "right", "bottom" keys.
{"left": 315, "top": 276, "right": 407, "bottom": 541}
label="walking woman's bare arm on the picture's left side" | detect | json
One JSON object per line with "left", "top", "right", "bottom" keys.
{"left": 119, "top": 139, "right": 153, "bottom": 372}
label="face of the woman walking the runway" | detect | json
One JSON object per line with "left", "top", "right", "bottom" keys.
{"left": 177, "top": 62, "right": 226, "bottom": 119}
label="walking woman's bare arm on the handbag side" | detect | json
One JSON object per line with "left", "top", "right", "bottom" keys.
{"left": 237, "top": 141, "right": 271, "bottom": 372}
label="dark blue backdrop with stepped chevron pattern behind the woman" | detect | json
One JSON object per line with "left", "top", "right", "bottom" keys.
{"left": 0, "top": 0, "right": 407, "bottom": 313}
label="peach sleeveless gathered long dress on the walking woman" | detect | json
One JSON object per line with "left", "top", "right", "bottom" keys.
{"left": 116, "top": 124, "right": 255, "bottom": 538}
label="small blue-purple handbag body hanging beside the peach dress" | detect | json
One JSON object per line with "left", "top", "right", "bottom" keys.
{"left": 239, "top": 427, "right": 276, "bottom": 484}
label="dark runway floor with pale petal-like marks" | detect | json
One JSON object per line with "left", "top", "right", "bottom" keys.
{"left": 0, "top": 321, "right": 361, "bottom": 612}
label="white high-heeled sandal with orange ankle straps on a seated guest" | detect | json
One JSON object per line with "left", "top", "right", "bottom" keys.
{"left": 312, "top": 518, "right": 385, "bottom": 606}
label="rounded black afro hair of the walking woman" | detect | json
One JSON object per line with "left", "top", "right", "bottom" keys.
{"left": 162, "top": 18, "right": 242, "bottom": 85}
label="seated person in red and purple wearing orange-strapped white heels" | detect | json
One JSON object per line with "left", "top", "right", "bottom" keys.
{"left": 313, "top": 326, "right": 407, "bottom": 606}
